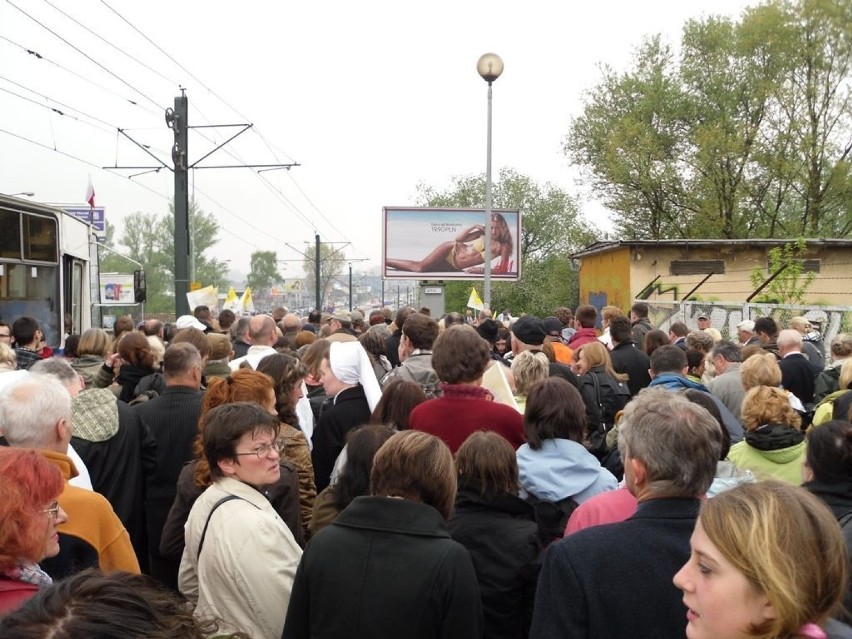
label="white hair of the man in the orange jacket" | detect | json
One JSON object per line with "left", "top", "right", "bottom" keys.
{"left": 0, "top": 375, "right": 71, "bottom": 448}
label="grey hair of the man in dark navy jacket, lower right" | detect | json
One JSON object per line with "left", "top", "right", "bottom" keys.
{"left": 618, "top": 388, "right": 722, "bottom": 497}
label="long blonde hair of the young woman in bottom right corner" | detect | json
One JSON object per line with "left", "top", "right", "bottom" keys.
{"left": 699, "top": 480, "right": 849, "bottom": 639}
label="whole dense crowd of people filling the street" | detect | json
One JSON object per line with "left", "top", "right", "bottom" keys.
{"left": 0, "top": 302, "right": 852, "bottom": 639}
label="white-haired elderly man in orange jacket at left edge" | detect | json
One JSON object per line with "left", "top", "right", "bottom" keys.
{"left": 0, "top": 375, "right": 139, "bottom": 579}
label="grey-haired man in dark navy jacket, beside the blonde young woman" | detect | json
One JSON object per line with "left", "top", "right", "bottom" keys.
{"left": 530, "top": 390, "right": 722, "bottom": 639}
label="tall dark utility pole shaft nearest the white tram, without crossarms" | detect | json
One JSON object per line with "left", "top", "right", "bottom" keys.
{"left": 172, "top": 90, "right": 190, "bottom": 317}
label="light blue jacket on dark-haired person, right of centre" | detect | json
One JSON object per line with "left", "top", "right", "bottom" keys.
{"left": 517, "top": 439, "right": 615, "bottom": 501}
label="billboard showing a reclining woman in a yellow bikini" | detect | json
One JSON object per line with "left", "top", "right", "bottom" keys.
{"left": 382, "top": 206, "right": 521, "bottom": 281}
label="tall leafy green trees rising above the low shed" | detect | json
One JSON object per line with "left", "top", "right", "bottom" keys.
{"left": 565, "top": 0, "right": 852, "bottom": 239}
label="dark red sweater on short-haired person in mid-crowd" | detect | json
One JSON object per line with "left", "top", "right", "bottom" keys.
{"left": 409, "top": 384, "right": 526, "bottom": 455}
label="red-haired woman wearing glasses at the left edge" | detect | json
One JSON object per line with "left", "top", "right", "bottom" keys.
{"left": 0, "top": 448, "right": 68, "bottom": 617}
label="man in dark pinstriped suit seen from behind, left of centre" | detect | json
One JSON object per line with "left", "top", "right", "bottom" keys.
{"left": 135, "top": 342, "right": 205, "bottom": 590}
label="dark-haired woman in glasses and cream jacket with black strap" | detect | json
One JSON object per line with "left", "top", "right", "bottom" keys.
{"left": 178, "top": 402, "right": 302, "bottom": 639}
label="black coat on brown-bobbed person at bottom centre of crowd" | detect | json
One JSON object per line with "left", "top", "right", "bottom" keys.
{"left": 282, "top": 497, "right": 482, "bottom": 639}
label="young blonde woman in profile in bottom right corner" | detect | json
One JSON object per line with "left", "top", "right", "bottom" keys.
{"left": 674, "top": 480, "right": 849, "bottom": 639}
